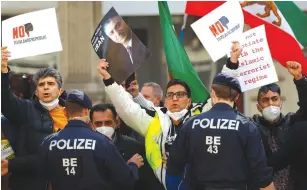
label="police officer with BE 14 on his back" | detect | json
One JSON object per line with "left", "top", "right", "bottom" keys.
{"left": 40, "top": 90, "right": 143, "bottom": 190}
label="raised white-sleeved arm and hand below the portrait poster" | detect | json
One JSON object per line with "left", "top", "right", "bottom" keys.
{"left": 97, "top": 60, "right": 155, "bottom": 136}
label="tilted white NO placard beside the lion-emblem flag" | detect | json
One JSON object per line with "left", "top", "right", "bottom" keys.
{"left": 191, "top": 1, "right": 244, "bottom": 62}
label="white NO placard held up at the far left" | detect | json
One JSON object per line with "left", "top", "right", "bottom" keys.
{"left": 2, "top": 8, "right": 62, "bottom": 60}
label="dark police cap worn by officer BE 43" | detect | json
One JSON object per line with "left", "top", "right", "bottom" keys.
{"left": 212, "top": 73, "right": 241, "bottom": 93}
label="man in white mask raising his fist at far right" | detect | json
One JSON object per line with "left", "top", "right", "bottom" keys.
{"left": 232, "top": 61, "right": 307, "bottom": 190}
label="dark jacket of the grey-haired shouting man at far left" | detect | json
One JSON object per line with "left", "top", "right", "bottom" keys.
{"left": 1, "top": 73, "right": 64, "bottom": 190}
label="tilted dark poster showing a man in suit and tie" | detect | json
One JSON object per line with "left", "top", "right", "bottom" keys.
{"left": 91, "top": 7, "right": 150, "bottom": 84}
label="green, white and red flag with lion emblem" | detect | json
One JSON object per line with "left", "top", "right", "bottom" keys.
{"left": 185, "top": 1, "right": 307, "bottom": 75}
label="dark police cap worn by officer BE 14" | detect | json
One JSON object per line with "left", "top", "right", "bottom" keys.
{"left": 66, "top": 90, "right": 92, "bottom": 109}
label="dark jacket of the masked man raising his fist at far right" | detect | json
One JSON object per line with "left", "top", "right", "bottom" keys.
{"left": 253, "top": 76, "right": 307, "bottom": 156}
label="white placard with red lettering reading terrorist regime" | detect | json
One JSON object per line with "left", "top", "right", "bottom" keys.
{"left": 238, "top": 25, "right": 278, "bottom": 92}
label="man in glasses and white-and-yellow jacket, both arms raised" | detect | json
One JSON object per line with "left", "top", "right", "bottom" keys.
{"left": 97, "top": 43, "right": 241, "bottom": 186}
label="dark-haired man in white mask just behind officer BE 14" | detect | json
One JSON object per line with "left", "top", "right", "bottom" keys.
{"left": 90, "top": 104, "right": 164, "bottom": 190}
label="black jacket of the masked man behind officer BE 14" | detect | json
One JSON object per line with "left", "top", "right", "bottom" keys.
{"left": 113, "top": 130, "right": 164, "bottom": 190}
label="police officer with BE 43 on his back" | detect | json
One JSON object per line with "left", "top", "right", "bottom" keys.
{"left": 167, "top": 73, "right": 274, "bottom": 190}
